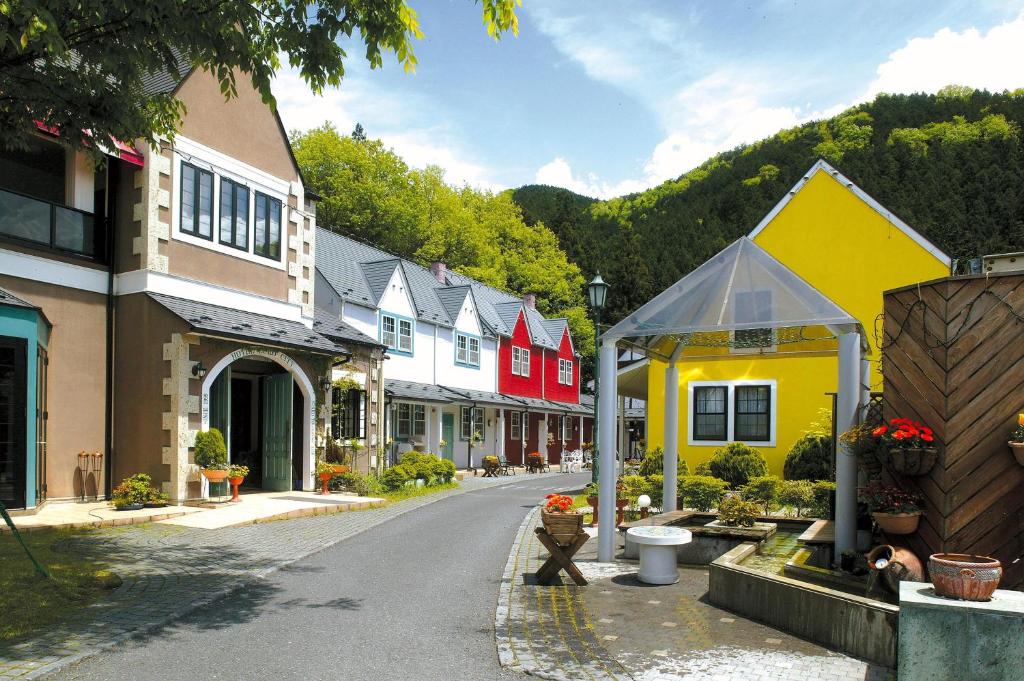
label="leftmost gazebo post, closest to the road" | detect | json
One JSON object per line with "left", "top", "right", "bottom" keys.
{"left": 597, "top": 340, "right": 618, "bottom": 563}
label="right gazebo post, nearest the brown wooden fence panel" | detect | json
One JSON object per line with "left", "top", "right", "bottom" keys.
{"left": 835, "top": 332, "right": 861, "bottom": 556}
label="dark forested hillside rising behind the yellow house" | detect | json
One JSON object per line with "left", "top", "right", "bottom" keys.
{"left": 512, "top": 86, "right": 1024, "bottom": 320}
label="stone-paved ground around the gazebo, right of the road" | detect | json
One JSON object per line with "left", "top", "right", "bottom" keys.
{"left": 496, "top": 511, "right": 889, "bottom": 681}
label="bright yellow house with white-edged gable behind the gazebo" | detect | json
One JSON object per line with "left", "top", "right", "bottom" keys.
{"left": 647, "top": 161, "right": 949, "bottom": 475}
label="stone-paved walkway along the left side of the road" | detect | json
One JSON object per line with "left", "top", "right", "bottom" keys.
{"left": 0, "top": 474, "right": 540, "bottom": 681}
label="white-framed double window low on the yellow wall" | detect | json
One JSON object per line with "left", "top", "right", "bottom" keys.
{"left": 686, "top": 379, "right": 778, "bottom": 446}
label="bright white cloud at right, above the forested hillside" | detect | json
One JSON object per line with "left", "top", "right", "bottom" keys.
{"left": 864, "top": 14, "right": 1024, "bottom": 99}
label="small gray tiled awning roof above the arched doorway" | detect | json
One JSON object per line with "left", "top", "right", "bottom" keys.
{"left": 146, "top": 293, "right": 349, "bottom": 355}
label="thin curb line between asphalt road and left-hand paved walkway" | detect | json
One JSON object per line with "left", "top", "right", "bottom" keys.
{"left": 12, "top": 480, "right": 528, "bottom": 681}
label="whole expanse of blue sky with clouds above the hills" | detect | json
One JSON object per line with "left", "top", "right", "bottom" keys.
{"left": 274, "top": 0, "right": 1024, "bottom": 198}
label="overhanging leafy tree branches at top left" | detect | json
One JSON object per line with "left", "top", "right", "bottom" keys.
{"left": 0, "top": 0, "right": 519, "bottom": 150}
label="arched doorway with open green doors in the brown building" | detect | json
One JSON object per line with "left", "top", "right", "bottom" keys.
{"left": 202, "top": 348, "right": 316, "bottom": 492}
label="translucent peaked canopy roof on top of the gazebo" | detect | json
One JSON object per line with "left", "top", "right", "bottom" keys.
{"left": 601, "top": 237, "right": 858, "bottom": 356}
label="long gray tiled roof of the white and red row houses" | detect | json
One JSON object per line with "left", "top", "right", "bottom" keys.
{"left": 316, "top": 227, "right": 561, "bottom": 348}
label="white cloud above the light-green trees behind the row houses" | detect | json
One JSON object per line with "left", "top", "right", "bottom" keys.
{"left": 273, "top": 69, "right": 504, "bottom": 190}
